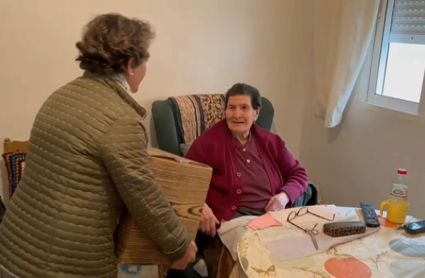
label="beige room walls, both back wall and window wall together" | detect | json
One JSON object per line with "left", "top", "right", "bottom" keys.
{"left": 0, "top": 0, "right": 425, "bottom": 218}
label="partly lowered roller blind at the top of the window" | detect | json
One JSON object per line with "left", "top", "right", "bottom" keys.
{"left": 390, "top": 0, "right": 425, "bottom": 35}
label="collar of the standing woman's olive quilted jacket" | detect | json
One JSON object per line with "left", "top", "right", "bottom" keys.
{"left": 83, "top": 71, "right": 147, "bottom": 120}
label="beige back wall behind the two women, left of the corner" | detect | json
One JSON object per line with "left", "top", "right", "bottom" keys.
{"left": 0, "top": 0, "right": 306, "bottom": 204}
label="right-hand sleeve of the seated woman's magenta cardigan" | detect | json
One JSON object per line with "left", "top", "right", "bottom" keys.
{"left": 277, "top": 137, "right": 308, "bottom": 205}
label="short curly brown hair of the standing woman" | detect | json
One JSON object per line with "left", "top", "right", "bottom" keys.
{"left": 76, "top": 13, "right": 155, "bottom": 75}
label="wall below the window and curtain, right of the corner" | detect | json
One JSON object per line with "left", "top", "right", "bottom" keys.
{"left": 299, "top": 3, "right": 425, "bottom": 218}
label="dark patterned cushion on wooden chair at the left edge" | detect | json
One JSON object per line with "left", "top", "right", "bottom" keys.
{"left": 3, "top": 152, "right": 27, "bottom": 198}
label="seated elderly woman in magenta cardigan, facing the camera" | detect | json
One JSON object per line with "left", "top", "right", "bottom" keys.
{"left": 186, "top": 84, "right": 308, "bottom": 277}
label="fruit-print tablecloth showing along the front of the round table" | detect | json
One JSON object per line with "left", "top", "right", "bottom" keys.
{"left": 237, "top": 207, "right": 425, "bottom": 278}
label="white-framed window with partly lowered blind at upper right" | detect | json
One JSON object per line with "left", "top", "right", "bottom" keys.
{"left": 367, "top": 0, "right": 425, "bottom": 114}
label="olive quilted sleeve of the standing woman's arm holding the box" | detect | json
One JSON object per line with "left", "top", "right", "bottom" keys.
{"left": 101, "top": 117, "right": 191, "bottom": 261}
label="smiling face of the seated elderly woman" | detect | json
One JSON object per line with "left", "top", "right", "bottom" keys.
{"left": 226, "top": 95, "right": 259, "bottom": 136}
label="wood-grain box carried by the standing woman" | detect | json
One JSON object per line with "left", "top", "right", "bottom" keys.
{"left": 115, "top": 149, "right": 212, "bottom": 265}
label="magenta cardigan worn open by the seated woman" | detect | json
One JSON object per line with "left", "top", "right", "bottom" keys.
{"left": 186, "top": 119, "right": 308, "bottom": 221}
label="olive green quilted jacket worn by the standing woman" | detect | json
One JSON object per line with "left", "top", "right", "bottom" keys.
{"left": 0, "top": 73, "right": 190, "bottom": 277}
